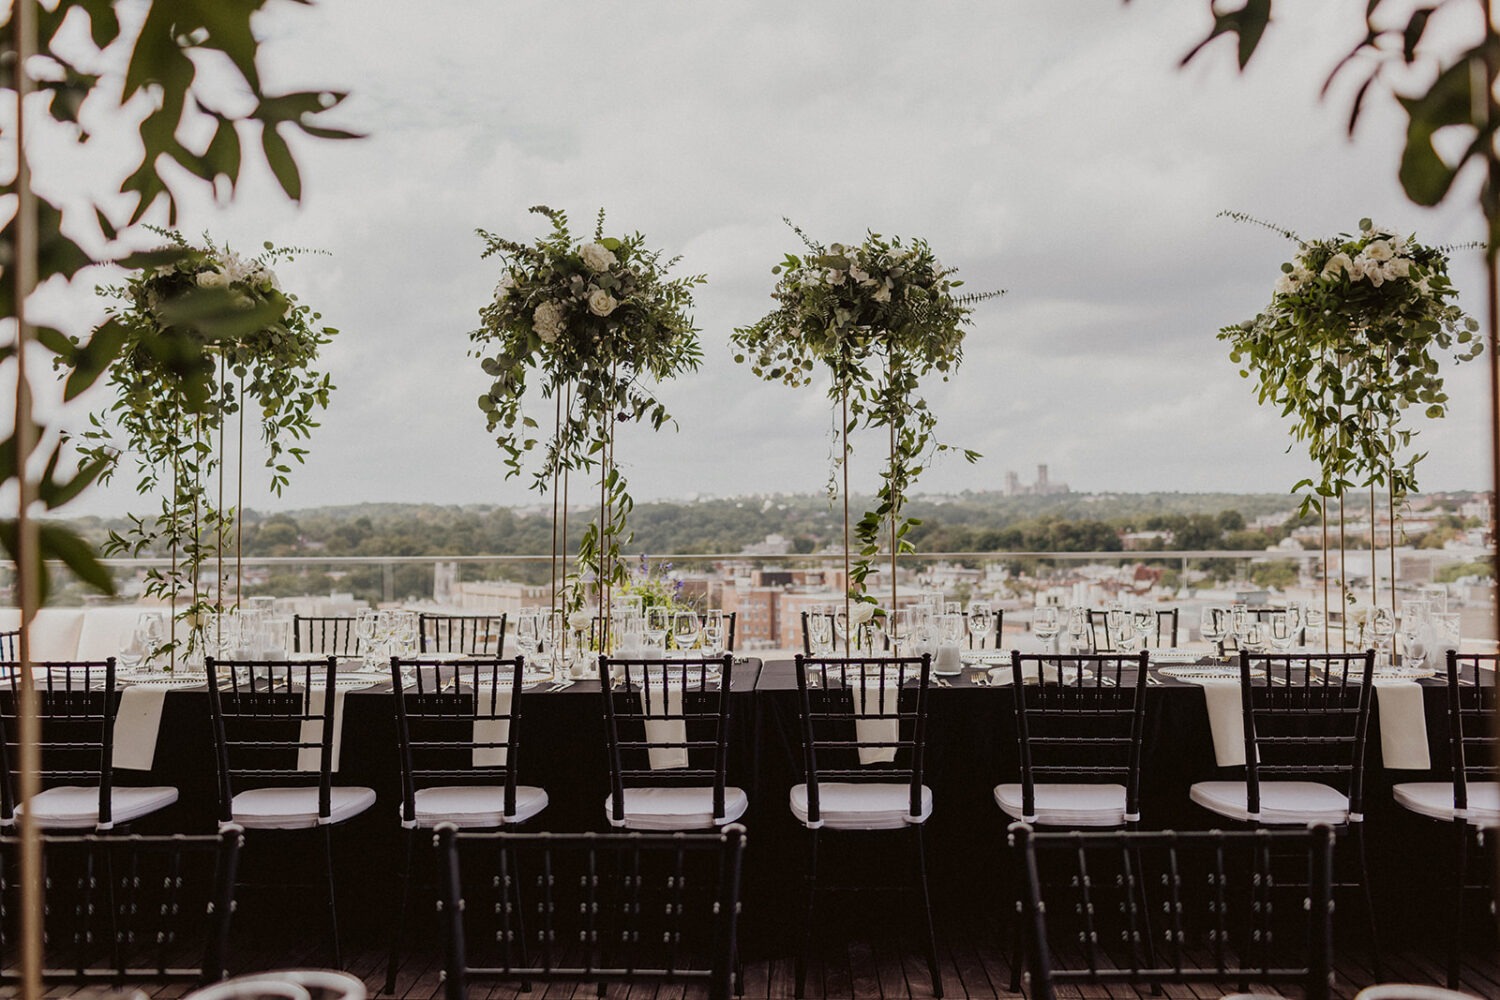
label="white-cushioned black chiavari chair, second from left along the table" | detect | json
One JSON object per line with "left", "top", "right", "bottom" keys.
{"left": 207, "top": 655, "right": 375, "bottom": 966}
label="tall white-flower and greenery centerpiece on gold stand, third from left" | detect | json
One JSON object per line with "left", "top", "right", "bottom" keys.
{"left": 732, "top": 222, "right": 1004, "bottom": 638}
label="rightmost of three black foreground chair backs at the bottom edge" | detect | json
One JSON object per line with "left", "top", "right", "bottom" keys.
{"left": 1010, "top": 823, "right": 1334, "bottom": 1000}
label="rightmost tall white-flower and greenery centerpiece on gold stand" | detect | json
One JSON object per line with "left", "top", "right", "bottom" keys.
{"left": 1218, "top": 213, "right": 1484, "bottom": 644}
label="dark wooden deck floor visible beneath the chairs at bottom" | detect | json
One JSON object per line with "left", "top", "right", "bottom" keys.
{"left": 64, "top": 925, "right": 1500, "bottom": 1000}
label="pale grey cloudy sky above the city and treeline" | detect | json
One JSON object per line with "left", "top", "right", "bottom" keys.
{"left": 29, "top": 0, "right": 1488, "bottom": 511}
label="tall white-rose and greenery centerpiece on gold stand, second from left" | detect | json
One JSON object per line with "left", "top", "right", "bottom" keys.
{"left": 470, "top": 205, "right": 705, "bottom": 632}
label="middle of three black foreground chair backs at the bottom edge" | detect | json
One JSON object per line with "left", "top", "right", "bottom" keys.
{"left": 437, "top": 823, "right": 744, "bottom": 1000}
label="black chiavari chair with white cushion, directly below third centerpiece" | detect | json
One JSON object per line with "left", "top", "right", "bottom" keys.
{"left": 791, "top": 655, "right": 942, "bottom": 997}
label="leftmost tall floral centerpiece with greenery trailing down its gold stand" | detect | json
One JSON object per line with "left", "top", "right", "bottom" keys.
{"left": 66, "top": 231, "right": 338, "bottom": 664}
